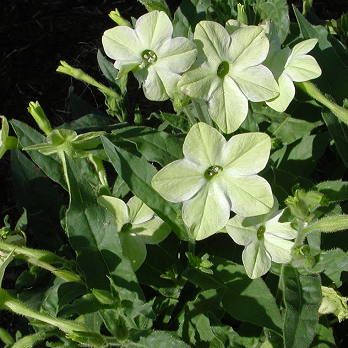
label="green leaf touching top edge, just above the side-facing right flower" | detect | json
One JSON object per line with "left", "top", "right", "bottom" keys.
{"left": 256, "top": 0, "right": 290, "bottom": 42}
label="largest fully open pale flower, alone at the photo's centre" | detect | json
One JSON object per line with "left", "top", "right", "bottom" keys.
{"left": 151, "top": 122, "right": 273, "bottom": 240}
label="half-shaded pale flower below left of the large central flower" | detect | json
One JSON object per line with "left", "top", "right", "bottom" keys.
{"left": 98, "top": 196, "right": 171, "bottom": 271}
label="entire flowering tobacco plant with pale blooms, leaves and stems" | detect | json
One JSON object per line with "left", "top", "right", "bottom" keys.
{"left": 0, "top": 0, "right": 348, "bottom": 348}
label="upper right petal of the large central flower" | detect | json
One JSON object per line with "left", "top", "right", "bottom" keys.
{"left": 221, "top": 133, "right": 271, "bottom": 176}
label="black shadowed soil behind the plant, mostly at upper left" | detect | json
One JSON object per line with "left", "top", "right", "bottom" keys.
{"left": 0, "top": 0, "right": 348, "bottom": 346}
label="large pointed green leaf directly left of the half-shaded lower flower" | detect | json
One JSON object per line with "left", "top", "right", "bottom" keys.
{"left": 66, "top": 157, "right": 142, "bottom": 299}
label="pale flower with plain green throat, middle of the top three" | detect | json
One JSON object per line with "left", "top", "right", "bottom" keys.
{"left": 178, "top": 21, "right": 279, "bottom": 133}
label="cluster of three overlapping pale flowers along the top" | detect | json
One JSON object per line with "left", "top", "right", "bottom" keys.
{"left": 103, "top": 11, "right": 321, "bottom": 133}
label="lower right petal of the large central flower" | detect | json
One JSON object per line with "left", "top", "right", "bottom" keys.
{"left": 223, "top": 175, "right": 273, "bottom": 216}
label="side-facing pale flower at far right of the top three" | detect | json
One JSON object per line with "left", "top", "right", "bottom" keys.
{"left": 264, "top": 39, "right": 321, "bottom": 112}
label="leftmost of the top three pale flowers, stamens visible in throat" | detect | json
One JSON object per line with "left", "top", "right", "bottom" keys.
{"left": 102, "top": 11, "right": 197, "bottom": 101}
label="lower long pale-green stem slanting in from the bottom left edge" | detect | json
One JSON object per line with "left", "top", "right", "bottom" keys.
{"left": 0, "top": 288, "right": 87, "bottom": 333}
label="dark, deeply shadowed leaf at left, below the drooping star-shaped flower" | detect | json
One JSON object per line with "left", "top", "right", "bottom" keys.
{"left": 11, "top": 149, "right": 66, "bottom": 251}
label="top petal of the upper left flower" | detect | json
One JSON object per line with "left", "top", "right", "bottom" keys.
{"left": 135, "top": 11, "right": 173, "bottom": 49}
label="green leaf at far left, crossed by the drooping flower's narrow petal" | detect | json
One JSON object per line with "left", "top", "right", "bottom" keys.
{"left": 11, "top": 120, "right": 67, "bottom": 189}
